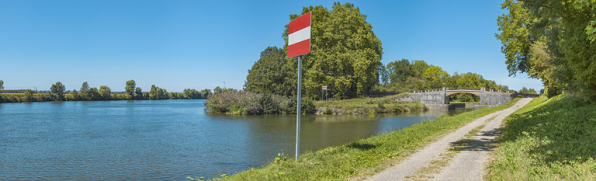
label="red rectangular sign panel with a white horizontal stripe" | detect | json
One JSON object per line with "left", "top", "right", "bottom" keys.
{"left": 288, "top": 12, "right": 311, "bottom": 58}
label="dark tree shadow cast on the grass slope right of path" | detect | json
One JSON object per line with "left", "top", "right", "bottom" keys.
{"left": 501, "top": 97, "right": 596, "bottom": 165}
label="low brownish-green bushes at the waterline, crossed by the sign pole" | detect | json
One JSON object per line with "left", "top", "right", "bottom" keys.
{"left": 205, "top": 91, "right": 316, "bottom": 115}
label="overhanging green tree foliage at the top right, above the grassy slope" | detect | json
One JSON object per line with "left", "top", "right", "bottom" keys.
{"left": 496, "top": 0, "right": 596, "bottom": 100}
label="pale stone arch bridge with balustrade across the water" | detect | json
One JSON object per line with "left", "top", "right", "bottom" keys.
{"left": 406, "top": 87, "right": 512, "bottom": 106}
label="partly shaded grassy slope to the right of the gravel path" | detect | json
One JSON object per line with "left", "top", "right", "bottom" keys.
{"left": 487, "top": 96, "right": 596, "bottom": 180}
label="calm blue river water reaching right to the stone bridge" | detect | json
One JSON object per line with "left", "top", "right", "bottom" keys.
{"left": 0, "top": 100, "right": 472, "bottom": 180}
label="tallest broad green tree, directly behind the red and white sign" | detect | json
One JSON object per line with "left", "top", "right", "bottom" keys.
{"left": 282, "top": 2, "right": 383, "bottom": 98}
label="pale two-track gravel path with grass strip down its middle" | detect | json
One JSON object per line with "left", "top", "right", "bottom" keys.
{"left": 368, "top": 98, "right": 532, "bottom": 180}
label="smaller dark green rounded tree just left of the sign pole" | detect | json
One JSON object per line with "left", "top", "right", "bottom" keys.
{"left": 246, "top": 47, "right": 297, "bottom": 96}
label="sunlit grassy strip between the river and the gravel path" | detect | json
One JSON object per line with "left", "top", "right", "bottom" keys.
{"left": 201, "top": 99, "right": 518, "bottom": 180}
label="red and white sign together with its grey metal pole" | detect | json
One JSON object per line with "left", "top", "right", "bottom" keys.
{"left": 288, "top": 12, "right": 311, "bottom": 161}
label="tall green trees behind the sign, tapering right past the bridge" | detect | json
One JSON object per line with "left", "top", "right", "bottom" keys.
{"left": 244, "top": 3, "right": 513, "bottom": 103}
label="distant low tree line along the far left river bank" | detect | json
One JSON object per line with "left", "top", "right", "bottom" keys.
{"left": 0, "top": 80, "right": 213, "bottom": 102}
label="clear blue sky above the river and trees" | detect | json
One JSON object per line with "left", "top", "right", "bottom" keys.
{"left": 0, "top": 0, "right": 542, "bottom": 92}
